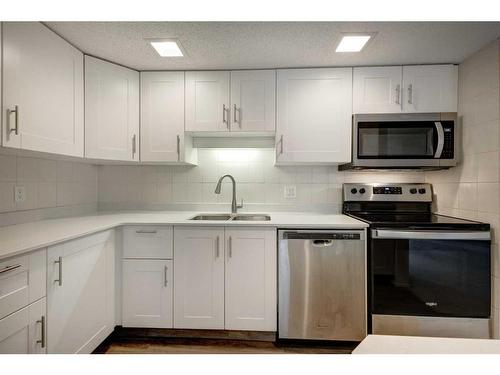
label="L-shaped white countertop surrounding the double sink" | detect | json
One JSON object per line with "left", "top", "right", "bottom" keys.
{"left": 0, "top": 211, "right": 368, "bottom": 259}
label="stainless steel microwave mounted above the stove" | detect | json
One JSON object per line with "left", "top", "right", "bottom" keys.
{"left": 339, "top": 113, "right": 458, "bottom": 170}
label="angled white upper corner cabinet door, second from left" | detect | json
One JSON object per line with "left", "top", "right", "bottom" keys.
{"left": 85, "top": 56, "right": 139, "bottom": 161}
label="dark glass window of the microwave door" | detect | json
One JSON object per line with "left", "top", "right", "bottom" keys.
{"left": 358, "top": 123, "right": 434, "bottom": 159}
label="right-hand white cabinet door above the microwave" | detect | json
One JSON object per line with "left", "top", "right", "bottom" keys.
{"left": 403, "top": 65, "right": 458, "bottom": 112}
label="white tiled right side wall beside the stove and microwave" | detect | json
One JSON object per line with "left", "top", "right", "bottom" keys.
{"left": 426, "top": 41, "right": 500, "bottom": 338}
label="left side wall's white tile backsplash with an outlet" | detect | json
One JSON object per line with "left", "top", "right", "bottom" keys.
{"left": 0, "top": 148, "right": 97, "bottom": 226}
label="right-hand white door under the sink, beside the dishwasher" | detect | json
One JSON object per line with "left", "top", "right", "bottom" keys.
{"left": 225, "top": 228, "right": 277, "bottom": 331}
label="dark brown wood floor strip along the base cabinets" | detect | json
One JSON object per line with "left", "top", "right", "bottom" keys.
{"left": 94, "top": 338, "right": 355, "bottom": 354}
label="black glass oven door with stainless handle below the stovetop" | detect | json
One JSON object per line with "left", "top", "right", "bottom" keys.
{"left": 370, "top": 229, "right": 491, "bottom": 318}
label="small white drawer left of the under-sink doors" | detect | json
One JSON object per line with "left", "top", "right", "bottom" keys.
{"left": 123, "top": 225, "right": 173, "bottom": 259}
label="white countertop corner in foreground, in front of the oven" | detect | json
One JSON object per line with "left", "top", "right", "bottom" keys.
{"left": 352, "top": 335, "right": 500, "bottom": 354}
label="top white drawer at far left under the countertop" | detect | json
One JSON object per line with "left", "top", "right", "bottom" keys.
{"left": 0, "top": 249, "right": 47, "bottom": 319}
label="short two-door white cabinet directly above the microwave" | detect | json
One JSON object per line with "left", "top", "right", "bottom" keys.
{"left": 353, "top": 65, "right": 458, "bottom": 113}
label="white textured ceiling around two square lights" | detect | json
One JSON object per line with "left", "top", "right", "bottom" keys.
{"left": 45, "top": 22, "right": 500, "bottom": 70}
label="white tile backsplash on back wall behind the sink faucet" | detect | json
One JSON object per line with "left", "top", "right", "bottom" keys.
{"left": 98, "top": 148, "right": 424, "bottom": 212}
